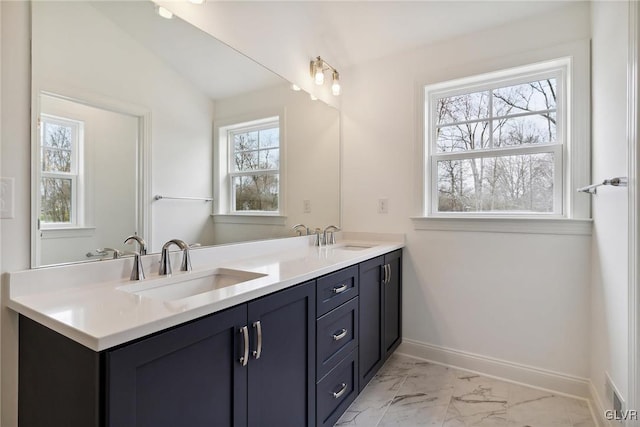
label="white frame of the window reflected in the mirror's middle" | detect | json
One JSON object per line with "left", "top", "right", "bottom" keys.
{"left": 213, "top": 113, "right": 286, "bottom": 221}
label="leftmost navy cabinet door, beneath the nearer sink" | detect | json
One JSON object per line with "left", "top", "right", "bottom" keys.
{"left": 106, "top": 305, "right": 247, "bottom": 427}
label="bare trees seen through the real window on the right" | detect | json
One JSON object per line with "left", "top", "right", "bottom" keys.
{"left": 432, "top": 77, "right": 559, "bottom": 213}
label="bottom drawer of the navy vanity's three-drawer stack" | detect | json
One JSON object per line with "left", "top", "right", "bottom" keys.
{"left": 316, "top": 347, "right": 358, "bottom": 427}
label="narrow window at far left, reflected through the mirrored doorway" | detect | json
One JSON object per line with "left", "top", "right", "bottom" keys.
{"left": 39, "top": 114, "right": 83, "bottom": 228}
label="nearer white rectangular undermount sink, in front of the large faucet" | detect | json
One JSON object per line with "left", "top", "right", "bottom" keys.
{"left": 118, "top": 268, "right": 266, "bottom": 301}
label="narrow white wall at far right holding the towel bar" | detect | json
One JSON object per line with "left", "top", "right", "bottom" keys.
{"left": 590, "top": 1, "right": 634, "bottom": 409}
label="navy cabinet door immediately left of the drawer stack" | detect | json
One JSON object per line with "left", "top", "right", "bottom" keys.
{"left": 246, "top": 281, "right": 316, "bottom": 427}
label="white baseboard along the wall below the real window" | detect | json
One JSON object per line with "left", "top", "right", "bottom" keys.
{"left": 398, "top": 338, "right": 592, "bottom": 400}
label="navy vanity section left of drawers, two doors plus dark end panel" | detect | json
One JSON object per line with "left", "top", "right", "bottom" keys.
{"left": 19, "top": 281, "right": 316, "bottom": 427}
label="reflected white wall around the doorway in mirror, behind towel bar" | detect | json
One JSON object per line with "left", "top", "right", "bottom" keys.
{"left": 33, "top": 2, "right": 213, "bottom": 252}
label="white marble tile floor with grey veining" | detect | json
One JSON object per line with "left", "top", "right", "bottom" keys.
{"left": 336, "top": 354, "right": 598, "bottom": 427}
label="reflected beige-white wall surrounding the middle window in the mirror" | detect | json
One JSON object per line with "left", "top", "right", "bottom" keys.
{"left": 214, "top": 84, "right": 340, "bottom": 243}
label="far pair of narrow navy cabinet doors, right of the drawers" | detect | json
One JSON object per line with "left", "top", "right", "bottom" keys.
{"left": 359, "top": 250, "right": 402, "bottom": 390}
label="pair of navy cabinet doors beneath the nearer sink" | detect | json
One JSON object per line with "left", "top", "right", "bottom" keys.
{"left": 106, "top": 282, "right": 315, "bottom": 427}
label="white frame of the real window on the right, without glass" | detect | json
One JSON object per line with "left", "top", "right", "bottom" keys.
{"left": 424, "top": 64, "right": 570, "bottom": 218}
